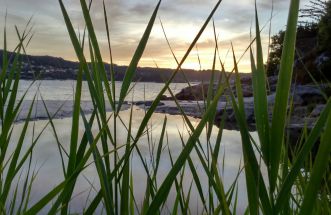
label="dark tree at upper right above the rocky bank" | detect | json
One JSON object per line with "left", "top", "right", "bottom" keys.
{"left": 267, "top": 0, "right": 331, "bottom": 83}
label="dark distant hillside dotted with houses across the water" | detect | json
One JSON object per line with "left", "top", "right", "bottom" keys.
{"left": 0, "top": 50, "right": 239, "bottom": 82}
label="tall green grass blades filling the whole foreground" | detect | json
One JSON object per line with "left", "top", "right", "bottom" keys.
{"left": 0, "top": 0, "right": 331, "bottom": 214}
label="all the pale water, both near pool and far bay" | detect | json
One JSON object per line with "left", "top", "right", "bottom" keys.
{"left": 7, "top": 81, "right": 258, "bottom": 214}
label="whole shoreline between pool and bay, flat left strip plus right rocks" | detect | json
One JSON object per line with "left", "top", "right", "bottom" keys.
{"left": 12, "top": 77, "right": 330, "bottom": 146}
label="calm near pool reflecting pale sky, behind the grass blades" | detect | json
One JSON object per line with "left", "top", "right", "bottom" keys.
{"left": 12, "top": 108, "right": 257, "bottom": 214}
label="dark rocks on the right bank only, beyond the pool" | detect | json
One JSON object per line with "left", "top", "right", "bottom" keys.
{"left": 144, "top": 76, "right": 331, "bottom": 142}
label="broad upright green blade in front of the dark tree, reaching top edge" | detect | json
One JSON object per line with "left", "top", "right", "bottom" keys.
{"left": 269, "top": 0, "right": 300, "bottom": 193}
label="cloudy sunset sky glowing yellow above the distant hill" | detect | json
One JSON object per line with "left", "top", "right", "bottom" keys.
{"left": 0, "top": 0, "right": 308, "bottom": 72}
